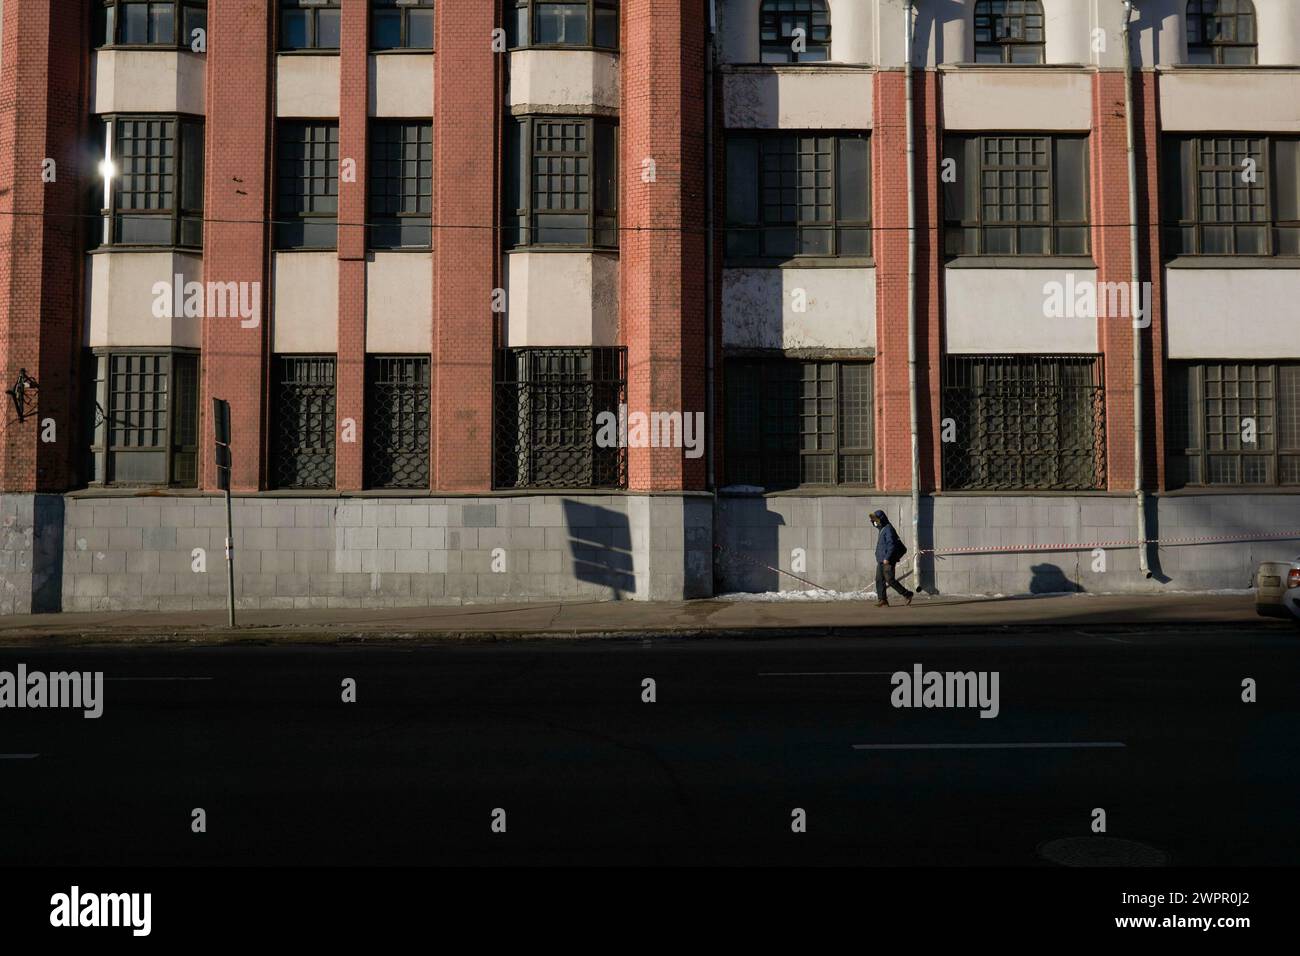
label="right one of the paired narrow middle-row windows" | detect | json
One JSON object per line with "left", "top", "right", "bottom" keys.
{"left": 369, "top": 121, "right": 433, "bottom": 248}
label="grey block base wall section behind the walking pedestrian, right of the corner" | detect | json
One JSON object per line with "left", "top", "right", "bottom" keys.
{"left": 714, "top": 494, "right": 1300, "bottom": 594}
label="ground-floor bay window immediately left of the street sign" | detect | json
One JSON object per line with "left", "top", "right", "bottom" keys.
{"left": 91, "top": 351, "right": 199, "bottom": 488}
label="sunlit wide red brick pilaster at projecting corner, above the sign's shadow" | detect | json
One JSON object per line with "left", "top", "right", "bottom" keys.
{"left": 619, "top": 0, "right": 707, "bottom": 490}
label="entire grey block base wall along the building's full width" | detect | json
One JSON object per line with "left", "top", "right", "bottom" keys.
{"left": 0, "top": 493, "right": 1284, "bottom": 614}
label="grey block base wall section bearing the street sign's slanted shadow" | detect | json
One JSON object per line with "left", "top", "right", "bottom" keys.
{"left": 61, "top": 494, "right": 712, "bottom": 610}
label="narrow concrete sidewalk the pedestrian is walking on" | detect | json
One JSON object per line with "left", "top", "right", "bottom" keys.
{"left": 0, "top": 594, "right": 1290, "bottom": 645}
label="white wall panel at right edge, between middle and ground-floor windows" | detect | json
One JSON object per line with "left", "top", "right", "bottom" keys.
{"left": 1165, "top": 269, "right": 1300, "bottom": 359}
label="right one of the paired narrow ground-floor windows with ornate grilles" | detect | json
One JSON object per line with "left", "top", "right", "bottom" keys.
{"left": 365, "top": 355, "right": 429, "bottom": 488}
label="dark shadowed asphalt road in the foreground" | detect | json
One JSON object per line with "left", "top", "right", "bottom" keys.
{"left": 0, "top": 626, "right": 1300, "bottom": 865}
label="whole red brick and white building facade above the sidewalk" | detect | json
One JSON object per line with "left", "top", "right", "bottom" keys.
{"left": 0, "top": 0, "right": 1300, "bottom": 613}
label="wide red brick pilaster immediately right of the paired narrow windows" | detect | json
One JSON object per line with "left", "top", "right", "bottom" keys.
{"left": 432, "top": 0, "right": 508, "bottom": 492}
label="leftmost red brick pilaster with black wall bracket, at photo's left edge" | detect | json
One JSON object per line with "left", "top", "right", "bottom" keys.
{"left": 0, "top": 0, "right": 95, "bottom": 492}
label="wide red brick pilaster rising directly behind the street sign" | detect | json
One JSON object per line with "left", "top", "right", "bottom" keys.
{"left": 199, "top": 3, "right": 274, "bottom": 490}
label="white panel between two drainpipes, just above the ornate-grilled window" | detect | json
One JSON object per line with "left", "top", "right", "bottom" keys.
{"left": 944, "top": 269, "right": 1097, "bottom": 355}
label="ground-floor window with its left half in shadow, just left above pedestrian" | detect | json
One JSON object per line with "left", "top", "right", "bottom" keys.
{"left": 725, "top": 359, "right": 875, "bottom": 490}
